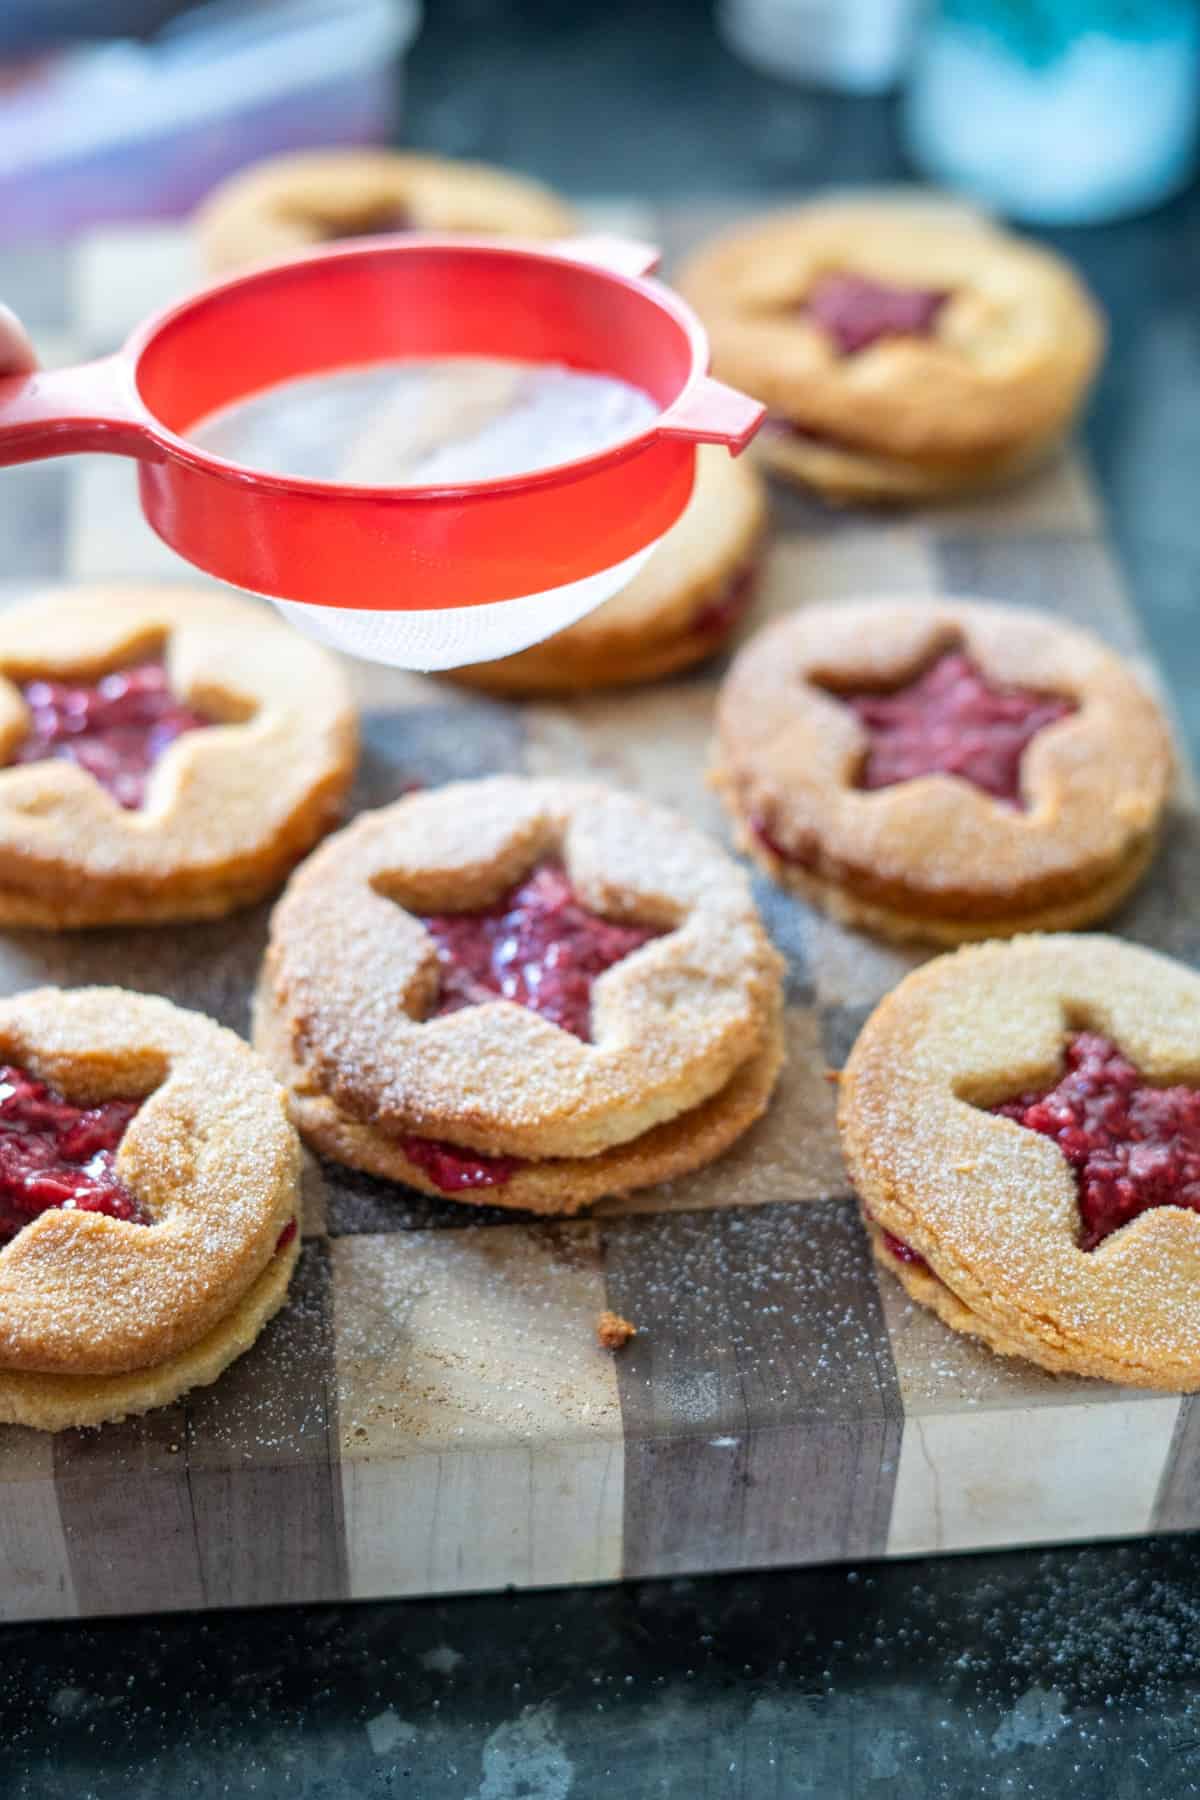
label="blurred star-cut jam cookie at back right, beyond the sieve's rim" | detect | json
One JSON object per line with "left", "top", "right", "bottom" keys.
{"left": 678, "top": 202, "right": 1105, "bottom": 500}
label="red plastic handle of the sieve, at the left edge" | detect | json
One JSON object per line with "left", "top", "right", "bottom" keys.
{"left": 0, "top": 356, "right": 157, "bottom": 464}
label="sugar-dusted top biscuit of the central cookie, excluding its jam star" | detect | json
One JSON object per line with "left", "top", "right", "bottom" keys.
{"left": 270, "top": 779, "right": 779, "bottom": 1157}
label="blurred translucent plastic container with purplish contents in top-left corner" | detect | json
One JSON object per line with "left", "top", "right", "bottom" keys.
{"left": 0, "top": 0, "right": 421, "bottom": 243}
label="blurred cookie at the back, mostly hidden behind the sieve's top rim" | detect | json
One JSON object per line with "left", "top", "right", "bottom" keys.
{"left": 196, "top": 149, "right": 576, "bottom": 272}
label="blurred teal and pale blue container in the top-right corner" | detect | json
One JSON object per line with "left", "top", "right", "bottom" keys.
{"left": 905, "top": 0, "right": 1200, "bottom": 225}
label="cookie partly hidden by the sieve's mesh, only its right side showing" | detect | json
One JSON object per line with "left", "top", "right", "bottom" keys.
{"left": 453, "top": 445, "right": 766, "bottom": 697}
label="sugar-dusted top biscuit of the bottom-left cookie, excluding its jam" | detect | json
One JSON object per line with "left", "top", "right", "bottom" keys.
{"left": 0, "top": 988, "right": 299, "bottom": 1389}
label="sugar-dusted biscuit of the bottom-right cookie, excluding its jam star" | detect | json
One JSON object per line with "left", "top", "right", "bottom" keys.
{"left": 840, "top": 936, "right": 1200, "bottom": 1388}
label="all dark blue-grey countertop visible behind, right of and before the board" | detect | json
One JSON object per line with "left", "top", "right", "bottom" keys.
{"left": 0, "top": 0, "right": 1200, "bottom": 1800}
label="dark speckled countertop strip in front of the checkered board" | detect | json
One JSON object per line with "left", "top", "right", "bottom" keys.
{"left": 0, "top": 1523, "right": 1200, "bottom": 1800}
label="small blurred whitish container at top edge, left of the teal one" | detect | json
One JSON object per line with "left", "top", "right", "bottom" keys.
{"left": 716, "top": 0, "right": 918, "bottom": 94}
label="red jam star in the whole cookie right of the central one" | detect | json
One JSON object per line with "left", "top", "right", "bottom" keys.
{"left": 837, "top": 650, "right": 1074, "bottom": 808}
